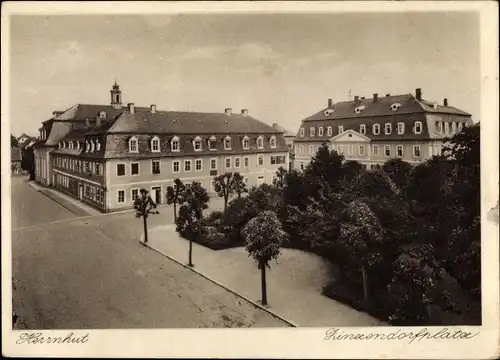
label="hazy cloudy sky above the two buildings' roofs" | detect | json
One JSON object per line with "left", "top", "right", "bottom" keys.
{"left": 10, "top": 12, "right": 480, "bottom": 136}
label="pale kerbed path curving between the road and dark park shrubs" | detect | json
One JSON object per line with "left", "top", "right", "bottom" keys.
{"left": 148, "top": 225, "right": 385, "bottom": 327}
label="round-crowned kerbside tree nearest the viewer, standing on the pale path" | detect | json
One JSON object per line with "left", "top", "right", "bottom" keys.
{"left": 242, "top": 211, "right": 287, "bottom": 305}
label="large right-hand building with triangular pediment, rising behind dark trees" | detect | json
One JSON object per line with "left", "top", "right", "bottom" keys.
{"left": 294, "top": 89, "right": 472, "bottom": 169}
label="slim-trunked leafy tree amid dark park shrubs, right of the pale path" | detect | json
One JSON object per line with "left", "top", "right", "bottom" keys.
{"left": 340, "top": 200, "right": 384, "bottom": 303}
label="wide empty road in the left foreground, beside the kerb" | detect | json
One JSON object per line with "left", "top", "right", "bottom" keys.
{"left": 12, "top": 179, "right": 286, "bottom": 329}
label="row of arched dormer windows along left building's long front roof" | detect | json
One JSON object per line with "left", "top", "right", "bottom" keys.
{"left": 123, "top": 135, "right": 277, "bottom": 153}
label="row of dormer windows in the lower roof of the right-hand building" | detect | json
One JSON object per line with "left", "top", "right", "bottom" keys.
{"left": 300, "top": 121, "right": 463, "bottom": 137}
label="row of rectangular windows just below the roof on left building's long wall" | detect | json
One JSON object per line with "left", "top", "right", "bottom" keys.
{"left": 116, "top": 155, "right": 286, "bottom": 176}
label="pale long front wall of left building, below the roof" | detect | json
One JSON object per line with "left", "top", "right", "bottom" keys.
{"left": 105, "top": 153, "right": 289, "bottom": 211}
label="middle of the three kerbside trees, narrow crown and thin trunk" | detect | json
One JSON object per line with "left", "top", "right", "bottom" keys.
{"left": 177, "top": 182, "right": 210, "bottom": 266}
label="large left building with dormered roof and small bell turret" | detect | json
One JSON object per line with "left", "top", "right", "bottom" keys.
{"left": 37, "top": 84, "right": 289, "bottom": 211}
